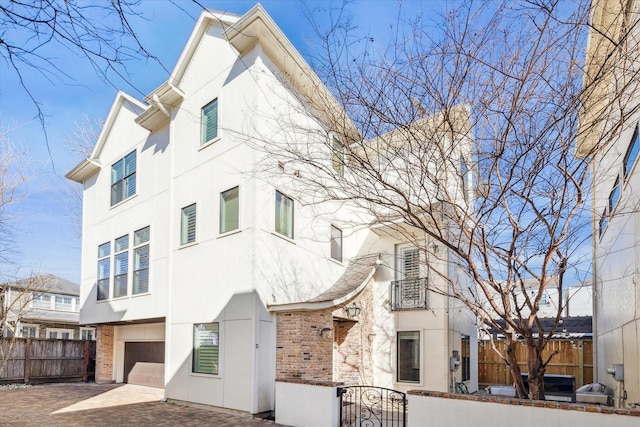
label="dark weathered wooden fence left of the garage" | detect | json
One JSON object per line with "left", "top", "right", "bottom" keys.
{"left": 0, "top": 338, "right": 96, "bottom": 383}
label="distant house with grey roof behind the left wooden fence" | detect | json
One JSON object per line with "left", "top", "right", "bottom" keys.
{"left": 0, "top": 274, "right": 95, "bottom": 340}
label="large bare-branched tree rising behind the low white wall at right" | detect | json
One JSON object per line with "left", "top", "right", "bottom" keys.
{"left": 268, "top": 0, "right": 640, "bottom": 399}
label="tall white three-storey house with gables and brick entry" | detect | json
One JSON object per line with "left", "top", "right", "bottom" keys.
{"left": 67, "top": 5, "right": 477, "bottom": 414}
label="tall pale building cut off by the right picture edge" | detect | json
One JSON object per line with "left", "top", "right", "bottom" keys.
{"left": 577, "top": 0, "right": 640, "bottom": 407}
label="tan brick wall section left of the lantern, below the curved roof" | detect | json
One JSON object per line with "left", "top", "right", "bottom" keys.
{"left": 276, "top": 309, "right": 334, "bottom": 381}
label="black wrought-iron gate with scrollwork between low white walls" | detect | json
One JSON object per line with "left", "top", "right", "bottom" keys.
{"left": 338, "top": 386, "right": 407, "bottom": 427}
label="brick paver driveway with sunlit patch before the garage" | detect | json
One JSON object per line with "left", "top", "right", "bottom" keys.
{"left": 0, "top": 383, "right": 278, "bottom": 427}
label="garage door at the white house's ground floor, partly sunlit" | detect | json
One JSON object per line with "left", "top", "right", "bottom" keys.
{"left": 124, "top": 341, "right": 164, "bottom": 387}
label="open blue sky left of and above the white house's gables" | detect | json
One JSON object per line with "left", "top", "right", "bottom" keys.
{"left": 0, "top": 0, "right": 436, "bottom": 283}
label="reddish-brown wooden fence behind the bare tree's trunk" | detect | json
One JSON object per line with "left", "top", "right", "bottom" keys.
{"left": 478, "top": 340, "right": 593, "bottom": 387}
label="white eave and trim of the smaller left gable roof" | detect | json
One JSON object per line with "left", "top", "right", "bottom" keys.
{"left": 64, "top": 91, "right": 147, "bottom": 183}
